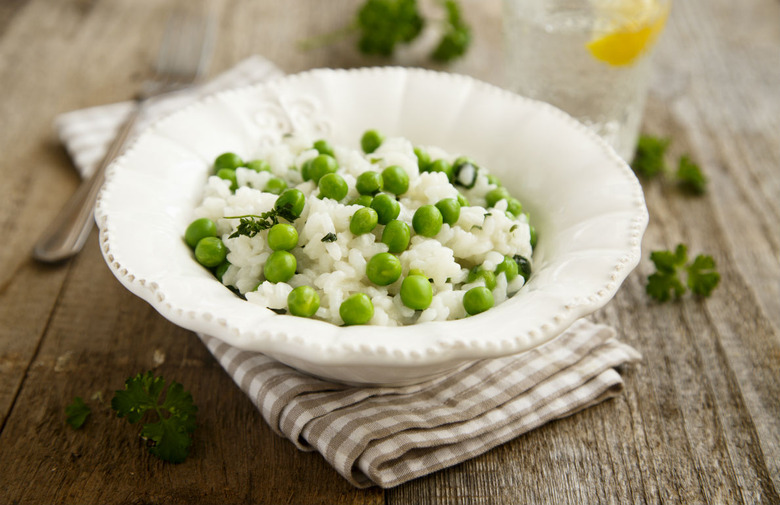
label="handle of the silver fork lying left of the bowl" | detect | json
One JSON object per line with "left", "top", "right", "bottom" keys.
{"left": 33, "top": 102, "right": 142, "bottom": 263}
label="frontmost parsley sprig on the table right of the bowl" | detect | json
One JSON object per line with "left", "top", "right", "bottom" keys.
{"left": 646, "top": 244, "right": 720, "bottom": 302}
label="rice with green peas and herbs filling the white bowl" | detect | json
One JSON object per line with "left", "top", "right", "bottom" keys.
{"left": 184, "top": 130, "right": 536, "bottom": 326}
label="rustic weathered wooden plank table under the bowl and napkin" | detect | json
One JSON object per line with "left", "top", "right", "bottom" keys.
{"left": 0, "top": 0, "right": 780, "bottom": 504}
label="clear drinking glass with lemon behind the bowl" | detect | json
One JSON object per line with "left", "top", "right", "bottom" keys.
{"left": 503, "top": 0, "right": 670, "bottom": 162}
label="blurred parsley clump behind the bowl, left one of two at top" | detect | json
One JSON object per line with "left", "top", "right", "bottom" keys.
{"left": 357, "top": 0, "right": 425, "bottom": 56}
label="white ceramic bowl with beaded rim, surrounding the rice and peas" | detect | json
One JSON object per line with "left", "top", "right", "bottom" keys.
{"left": 96, "top": 68, "right": 648, "bottom": 384}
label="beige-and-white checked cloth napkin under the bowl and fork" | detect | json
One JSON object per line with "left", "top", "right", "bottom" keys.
{"left": 56, "top": 57, "right": 640, "bottom": 488}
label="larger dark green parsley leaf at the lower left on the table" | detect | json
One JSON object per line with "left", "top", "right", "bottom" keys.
{"left": 111, "top": 372, "right": 198, "bottom": 463}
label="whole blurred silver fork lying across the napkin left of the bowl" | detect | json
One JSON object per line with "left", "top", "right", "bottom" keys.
{"left": 33, "top": 5, "right": 215, "bottom": 263}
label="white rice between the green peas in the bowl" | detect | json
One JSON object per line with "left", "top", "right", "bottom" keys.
{"left": 193, "top": 132, "right": 532, "bottom": 326}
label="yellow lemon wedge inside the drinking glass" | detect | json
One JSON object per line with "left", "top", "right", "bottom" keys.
{"left": 587, "top": 0, "right": 669, "bottom": 66}
